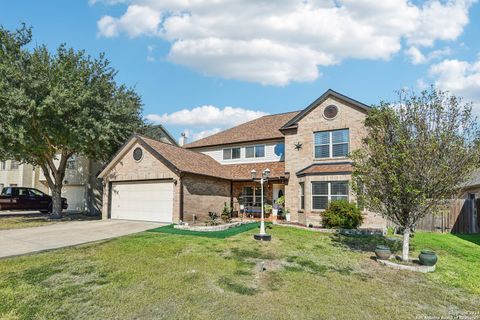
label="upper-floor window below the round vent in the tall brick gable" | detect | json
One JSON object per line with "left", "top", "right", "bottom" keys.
{"left": 314, "top": 129, "right": 349, "bottom": 159}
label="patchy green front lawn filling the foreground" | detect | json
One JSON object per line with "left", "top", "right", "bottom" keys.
{"left": 0, "top": 226, "right": 480, "bottom": 319}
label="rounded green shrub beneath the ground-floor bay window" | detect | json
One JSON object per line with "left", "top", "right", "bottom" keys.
{"left": 322, "top": 200, "right": 363, "bottom": 229}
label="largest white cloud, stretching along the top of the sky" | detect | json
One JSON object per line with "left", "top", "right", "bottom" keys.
{"left": 94, "top": 0, "right": 475, "bottom": 85}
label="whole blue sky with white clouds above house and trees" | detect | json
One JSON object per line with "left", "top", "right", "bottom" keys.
{"left": 0, "top": 0, "right": 480, "bottom": 139}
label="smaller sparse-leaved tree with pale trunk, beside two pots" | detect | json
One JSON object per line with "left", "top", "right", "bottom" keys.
{"left": 352, "top": 87, "right": 480, "bottom": 260}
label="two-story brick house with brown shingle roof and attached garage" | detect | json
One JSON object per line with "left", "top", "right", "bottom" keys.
{"left": 99, "top": 90, "right": 385, "bottom": 227}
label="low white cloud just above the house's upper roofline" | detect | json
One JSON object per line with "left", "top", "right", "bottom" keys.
{"left": 146, "top": 105, "right": 267, "bottom": 140}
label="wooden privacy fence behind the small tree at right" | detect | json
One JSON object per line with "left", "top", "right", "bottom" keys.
{"left": 388, "top": 199, "right": 480, "bottom": 233}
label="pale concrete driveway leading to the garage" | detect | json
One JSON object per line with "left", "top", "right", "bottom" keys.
{"left": 0, "top": 220, "right": 165, "bottom": 258}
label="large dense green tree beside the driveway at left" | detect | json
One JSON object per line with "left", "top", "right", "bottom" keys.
{"left": 0, "top": 25, "right": 142, "bottom": 217}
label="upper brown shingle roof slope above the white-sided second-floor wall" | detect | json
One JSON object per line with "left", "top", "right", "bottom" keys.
{"left": 184, "top": 111, "right": 299, "bottom": 148}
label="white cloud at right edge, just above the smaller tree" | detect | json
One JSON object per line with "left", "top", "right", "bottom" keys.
{"left": 430, "top": 57, "right": 480, "bottom": 112}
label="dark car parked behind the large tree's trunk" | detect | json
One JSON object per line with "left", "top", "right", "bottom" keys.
{"left": 0, "top": 187, "right": 68, "bottom": 213}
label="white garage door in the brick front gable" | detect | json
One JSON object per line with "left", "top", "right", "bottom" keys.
{"left": 111, "top": 181, "right": 173, "bottom": 222}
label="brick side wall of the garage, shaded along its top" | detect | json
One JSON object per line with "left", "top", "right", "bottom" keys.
{"left": 182, "top": 174, "right": 230, "bottom": 223}
